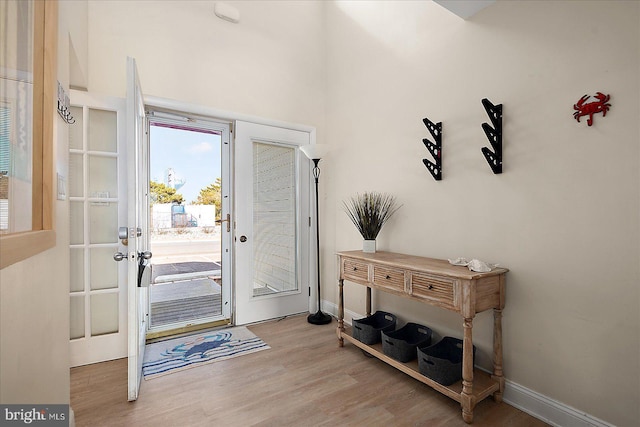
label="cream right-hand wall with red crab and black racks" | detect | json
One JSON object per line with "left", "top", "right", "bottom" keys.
{"left": 321, "top": 1, "right": 640, "bottom": 426}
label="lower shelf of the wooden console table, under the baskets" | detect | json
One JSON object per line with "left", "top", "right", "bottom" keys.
{"left": 337, "top": 327, "right": 500, "bottom": 407}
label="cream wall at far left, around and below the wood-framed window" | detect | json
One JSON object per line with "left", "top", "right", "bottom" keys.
{"left": 0, "top": 1, "right": 87, "bottom": 404}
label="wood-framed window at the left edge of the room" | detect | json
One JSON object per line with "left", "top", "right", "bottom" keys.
{"left": 0, "top": 0, "right": 58, "bottom": 268}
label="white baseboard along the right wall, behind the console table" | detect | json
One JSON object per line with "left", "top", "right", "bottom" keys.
{"left": 322, "top": 300, "right": 614, "bottom": 427}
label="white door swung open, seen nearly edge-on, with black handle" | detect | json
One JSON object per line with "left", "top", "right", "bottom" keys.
{"left": 121, "top": 58, "right": 151, "bottom": 401}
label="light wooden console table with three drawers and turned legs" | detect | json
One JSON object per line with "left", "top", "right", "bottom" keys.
{"left": 337, "top": 251, "right": 509, "bottom": 423}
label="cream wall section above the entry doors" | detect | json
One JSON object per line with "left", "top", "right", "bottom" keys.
{"left": 89, "top": 0, "right": 325, "bottom": 133}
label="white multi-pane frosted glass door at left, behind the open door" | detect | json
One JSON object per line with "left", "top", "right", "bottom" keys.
{"left": 68, "top": 91, "right": 127, "bottom": 366}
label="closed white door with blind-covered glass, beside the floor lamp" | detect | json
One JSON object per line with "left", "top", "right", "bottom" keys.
{"left": 234, "top": 121, "right": 311, "bottom": 325}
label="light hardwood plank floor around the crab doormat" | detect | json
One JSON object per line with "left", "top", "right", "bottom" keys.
{"left": 71, "top": 316, "right": 546, "bottom": 427}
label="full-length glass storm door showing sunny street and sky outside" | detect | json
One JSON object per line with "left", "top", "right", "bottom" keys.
{"left": 149, "top": 112, "right": 231, "bottom": 336}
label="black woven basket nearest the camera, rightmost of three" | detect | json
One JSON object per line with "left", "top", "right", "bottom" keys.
{"left": 417, "top": 337, "right": 476, "bottom": 385}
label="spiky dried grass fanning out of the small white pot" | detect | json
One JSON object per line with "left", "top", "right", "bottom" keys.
{"left": 343, "top": 192, "right": 402, "bottom": 240}
